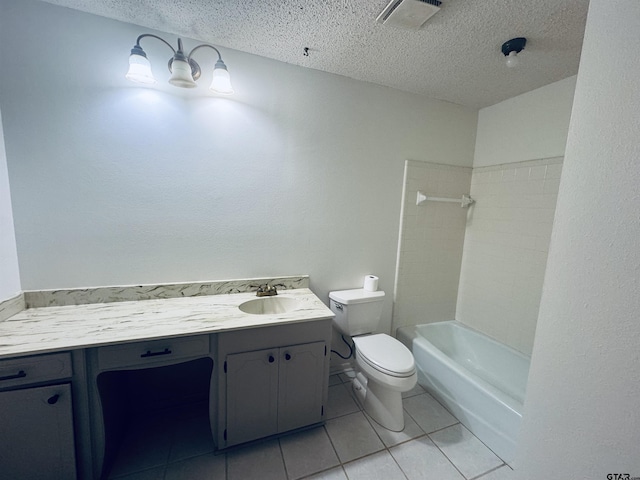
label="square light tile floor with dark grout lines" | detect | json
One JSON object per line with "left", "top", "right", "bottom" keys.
{"left": 109, "top": 372, "right": 513, "bottom": 480}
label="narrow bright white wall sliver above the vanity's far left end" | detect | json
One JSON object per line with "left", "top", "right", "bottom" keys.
{"left": 0, "top": 108, "right": 22, "bottom": 302}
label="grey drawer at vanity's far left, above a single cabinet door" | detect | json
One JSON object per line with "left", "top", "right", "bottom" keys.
{"left": 0, "top": 352, "right": 73, "bottom": 389}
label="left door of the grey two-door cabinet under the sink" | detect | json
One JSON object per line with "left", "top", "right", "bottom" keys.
{"left": 226, "top": 348, "right": 279, "bottom": 446}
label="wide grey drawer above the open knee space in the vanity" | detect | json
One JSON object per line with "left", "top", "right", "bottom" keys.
{"left": 98, "top": 335, "right": 209, "bottom": 370}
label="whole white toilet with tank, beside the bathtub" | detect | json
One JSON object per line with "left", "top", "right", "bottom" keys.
{"left": 329, "top": 288, "right": 418, "bottom": 432}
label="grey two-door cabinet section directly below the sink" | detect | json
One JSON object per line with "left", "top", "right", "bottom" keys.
{"left": 217, "top": 319, "right": 331, "bottom": 448}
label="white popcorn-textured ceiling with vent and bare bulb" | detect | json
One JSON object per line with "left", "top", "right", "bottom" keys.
{"left": 38, "top": 0, "right": 589, "bottom": 107}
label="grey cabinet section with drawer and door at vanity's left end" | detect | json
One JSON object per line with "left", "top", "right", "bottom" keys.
{"left": 0, "top": 353, "right": 76, "bottom": 480}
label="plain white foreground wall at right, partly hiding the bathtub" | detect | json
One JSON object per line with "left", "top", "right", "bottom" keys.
{"left": 516, "top": 0, "right": 640, "bottom": 480}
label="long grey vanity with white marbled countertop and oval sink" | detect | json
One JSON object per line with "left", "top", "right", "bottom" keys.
{"left": 0, "top": 277, "right": 333, "bottom": 479}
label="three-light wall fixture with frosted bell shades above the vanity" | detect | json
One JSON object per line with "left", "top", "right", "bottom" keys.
{"left": 125, "top": 33, "right": 233, "bottom": 95}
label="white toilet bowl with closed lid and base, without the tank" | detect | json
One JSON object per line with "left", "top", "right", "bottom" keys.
{"left": 353, "top": 334, "right": 418, "bottom": 432}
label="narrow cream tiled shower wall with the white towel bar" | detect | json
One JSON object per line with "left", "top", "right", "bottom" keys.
{"left": 393, "top": 160, "right": 471, "bottom": 332}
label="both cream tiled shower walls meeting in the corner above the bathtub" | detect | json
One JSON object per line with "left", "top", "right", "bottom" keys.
{"left": 393, "top": 157, "right": 563, "bottom": 355}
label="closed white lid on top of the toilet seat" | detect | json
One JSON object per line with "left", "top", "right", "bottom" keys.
{"left": 353, "top": 333, "right": 415, "bottom": 377}
